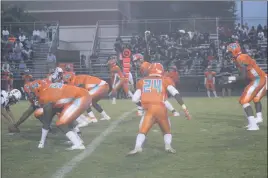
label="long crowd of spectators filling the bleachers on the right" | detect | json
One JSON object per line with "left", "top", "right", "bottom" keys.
{"left": 114, "top": 24, "right": 267, "bottom": 74}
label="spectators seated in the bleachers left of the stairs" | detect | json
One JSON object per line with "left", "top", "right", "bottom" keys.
{"left": 1, "top": 24, "right": 52, "bottom": 90}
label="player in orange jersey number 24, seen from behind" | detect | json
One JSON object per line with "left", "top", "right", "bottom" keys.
{"left": 129, "top": 63, "right": 190, "bottom": 155}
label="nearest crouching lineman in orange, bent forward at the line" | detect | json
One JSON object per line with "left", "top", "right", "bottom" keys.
{"left": 31, "top": 80, "right": 91, "bottom": 150}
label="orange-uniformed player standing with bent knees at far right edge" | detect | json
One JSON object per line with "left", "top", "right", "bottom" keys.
{"left": 227, "top": 43, "right": 267, "bottom": 130}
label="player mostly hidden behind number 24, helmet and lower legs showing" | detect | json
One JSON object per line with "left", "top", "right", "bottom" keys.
{"left": 133, "top": 54, "right": 180, "bottom": 116}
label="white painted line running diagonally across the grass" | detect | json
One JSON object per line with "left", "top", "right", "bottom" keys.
{"left": 51, "top": 108, "right": 136, "bottom": 178}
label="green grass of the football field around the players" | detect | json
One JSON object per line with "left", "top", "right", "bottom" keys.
{"left": 1, "top": 97, "right": 267, "bottom": 178}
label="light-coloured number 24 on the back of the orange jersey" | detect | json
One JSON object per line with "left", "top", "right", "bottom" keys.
{"left": 143, "top": 79, "right": 162, "bottom": 93}
